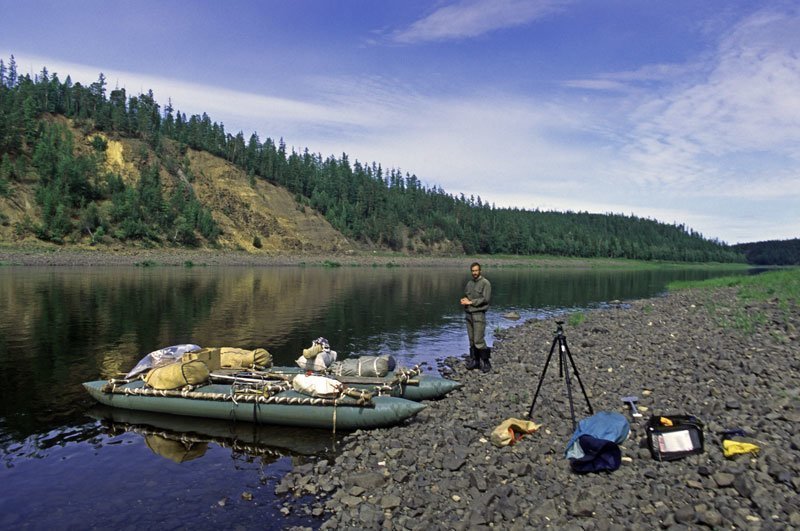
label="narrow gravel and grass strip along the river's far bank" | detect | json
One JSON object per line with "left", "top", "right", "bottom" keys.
{"left": 0, "top": 243, "right": 751, "bottom": 269}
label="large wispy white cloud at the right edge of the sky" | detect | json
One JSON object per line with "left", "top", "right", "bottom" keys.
{"left": 608, "top": 7, "right": 800, "bottom": 197}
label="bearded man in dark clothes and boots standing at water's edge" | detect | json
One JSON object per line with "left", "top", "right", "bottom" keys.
{"left": 461, "top": 262, "right": 492, "bottom": 372}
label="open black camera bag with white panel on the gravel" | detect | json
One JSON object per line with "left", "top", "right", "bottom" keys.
{"left": 647, "top": 415, "right": 704, "bottom": 461}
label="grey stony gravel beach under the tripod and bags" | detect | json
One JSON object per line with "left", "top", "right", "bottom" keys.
{"left": 276, "top": 288, "right": 800, "bottom": 530}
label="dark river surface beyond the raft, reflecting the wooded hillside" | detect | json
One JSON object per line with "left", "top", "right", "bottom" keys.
{"left": 0, "top": 266, "right": 744, "bottom": 437}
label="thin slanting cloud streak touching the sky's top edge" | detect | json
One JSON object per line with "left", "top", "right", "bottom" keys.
{"left": 391, "top": 0, "right": 570, "bottom": 44}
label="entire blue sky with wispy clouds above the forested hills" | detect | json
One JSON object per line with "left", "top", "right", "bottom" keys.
{"left": 0, "top": 0, "right": 800, "bottom": 243}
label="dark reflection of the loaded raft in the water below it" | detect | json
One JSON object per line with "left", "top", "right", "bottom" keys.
{"left": 87, "top": 405, "right": 338, "bottom": 463}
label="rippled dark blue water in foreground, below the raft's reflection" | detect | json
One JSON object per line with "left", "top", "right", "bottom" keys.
{"left": 0, "top": 413, "right": 324, "bottom": 530}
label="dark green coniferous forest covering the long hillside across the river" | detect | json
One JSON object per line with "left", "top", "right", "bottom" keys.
{"left": 0, "top": 55, "right": 744, "bottom": 262}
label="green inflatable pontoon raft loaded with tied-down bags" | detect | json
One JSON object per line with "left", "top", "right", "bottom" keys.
{"left": 83, "top": 338, "right": 461, "bottom": 430}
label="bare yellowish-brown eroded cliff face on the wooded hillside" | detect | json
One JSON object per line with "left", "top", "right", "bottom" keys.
{"left": 0, "top": 117, "right": 353, "bottom": 254}
